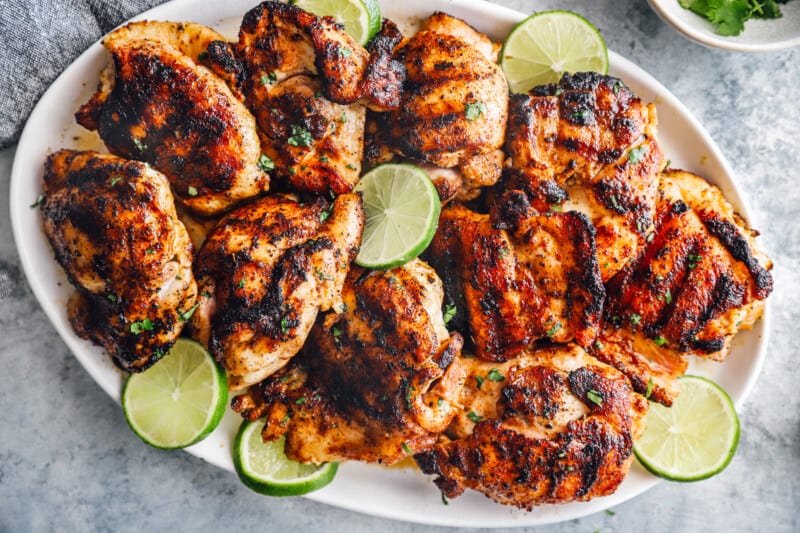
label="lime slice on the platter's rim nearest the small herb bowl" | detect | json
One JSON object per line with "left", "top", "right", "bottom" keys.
{"left": 500, "top": 11, "right": 608, "bottom": 93}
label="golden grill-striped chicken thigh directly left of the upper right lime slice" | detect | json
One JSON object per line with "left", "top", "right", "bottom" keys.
{"left": 388, "top": 13, "right": 508, "bottom": 199}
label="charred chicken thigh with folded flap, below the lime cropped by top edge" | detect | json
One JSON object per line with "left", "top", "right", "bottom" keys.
{"left": 209, "top": 2, "right": 403, "bottom": 194}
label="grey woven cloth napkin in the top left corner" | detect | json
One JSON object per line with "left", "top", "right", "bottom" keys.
{"left": 0, "top": 0, "right": 165, "bottom": 148}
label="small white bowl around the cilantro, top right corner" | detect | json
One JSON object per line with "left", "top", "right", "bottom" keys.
{"left": 647, "top": 0, "right": 800, "bottom": 52}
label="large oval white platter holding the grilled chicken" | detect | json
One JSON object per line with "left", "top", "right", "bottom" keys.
{"left": 10, "top": 0, "right": 768, "bottom": 527}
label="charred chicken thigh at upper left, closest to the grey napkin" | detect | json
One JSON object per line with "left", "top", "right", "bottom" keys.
{"left": 76, "top": 21, "right": 269, "bottom": 215}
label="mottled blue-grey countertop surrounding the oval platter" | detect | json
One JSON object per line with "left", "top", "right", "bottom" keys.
{"left": 0, "top": 0, "right": 800, "bottom": 533}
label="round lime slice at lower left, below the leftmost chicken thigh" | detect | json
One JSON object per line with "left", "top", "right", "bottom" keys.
{"left": 122, "top": 339, "right": 228, "bottom": 450}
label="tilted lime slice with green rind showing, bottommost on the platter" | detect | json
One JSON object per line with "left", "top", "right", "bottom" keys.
{"left": 233, "top": 420, "right": 339, "bottom": 496}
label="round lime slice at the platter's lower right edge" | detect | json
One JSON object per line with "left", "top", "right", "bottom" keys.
{"left": 633, "top": 376, "right": 739, "bottom": 481}
